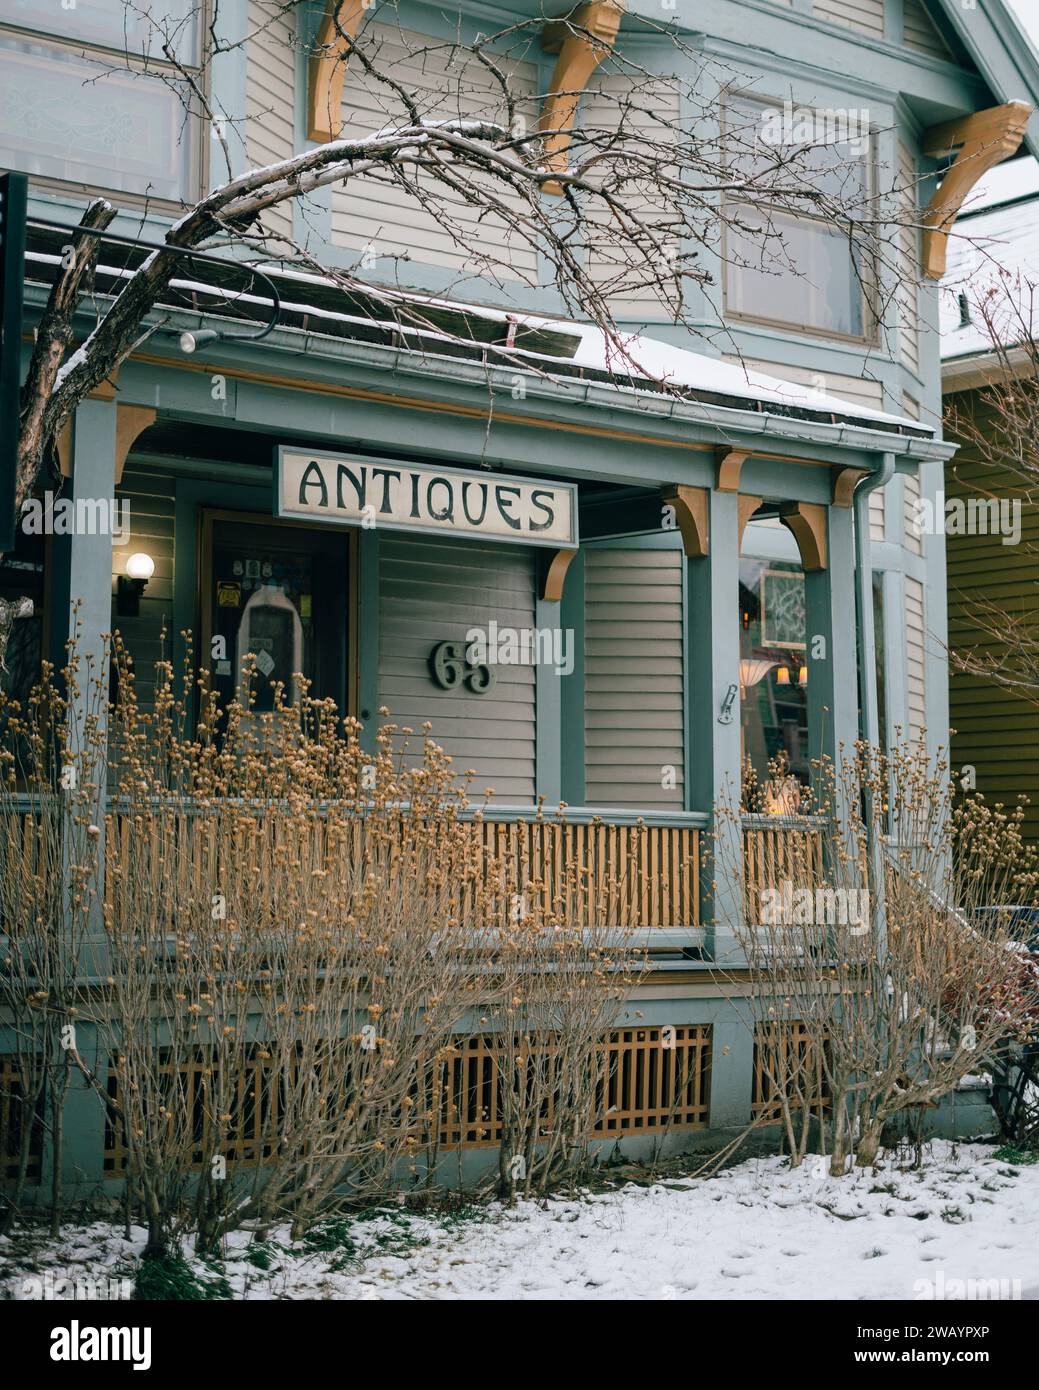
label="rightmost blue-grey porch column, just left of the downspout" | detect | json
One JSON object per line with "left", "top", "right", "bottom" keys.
{"left": 804, "top": 506, "right": 858, "bottom": 765}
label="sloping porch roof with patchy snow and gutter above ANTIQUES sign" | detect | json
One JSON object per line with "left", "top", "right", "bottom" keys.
{"left": 26, "top": 231, "right": 953, "bottom": 459}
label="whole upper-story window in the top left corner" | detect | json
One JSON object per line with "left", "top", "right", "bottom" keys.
{"left": 0, "top": 0, "right": 202, "bottom": 203}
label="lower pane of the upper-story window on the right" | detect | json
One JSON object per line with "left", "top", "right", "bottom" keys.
{"left": 725, "top": 204, "right": 865, "bottom": 338}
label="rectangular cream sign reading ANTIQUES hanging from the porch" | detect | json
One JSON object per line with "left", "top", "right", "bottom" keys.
{"left": 274, "top": 445, "right": 577, "bottom": 549}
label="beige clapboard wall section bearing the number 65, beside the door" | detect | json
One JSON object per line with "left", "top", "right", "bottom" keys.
{"left": 378, "top": 534, "right": 534, "bottom": 802}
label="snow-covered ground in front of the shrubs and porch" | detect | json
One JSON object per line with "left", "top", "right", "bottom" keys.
{"left": 0, "top": 1144, "right": 1039, "bottom": 1300}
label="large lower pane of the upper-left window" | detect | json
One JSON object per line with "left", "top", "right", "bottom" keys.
{"left": 0, "top": 35, "right": 199, "bottom": 202}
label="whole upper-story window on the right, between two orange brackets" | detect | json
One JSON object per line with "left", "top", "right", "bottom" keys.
{"left": 722, "top": 97, "right": 875, "bottom": 341}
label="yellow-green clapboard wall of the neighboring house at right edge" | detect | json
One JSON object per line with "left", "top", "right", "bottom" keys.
{"left": 946, "top": 395, "right": 1039, "bottom": 841}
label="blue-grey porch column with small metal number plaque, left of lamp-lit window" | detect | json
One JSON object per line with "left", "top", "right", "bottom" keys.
{"left": 686, "top": 489, "right": 743, "bottom": 963}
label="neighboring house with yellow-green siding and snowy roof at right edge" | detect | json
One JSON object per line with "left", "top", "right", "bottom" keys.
{"left": 942, "top": 184, "right": 1039, "bottom": 841}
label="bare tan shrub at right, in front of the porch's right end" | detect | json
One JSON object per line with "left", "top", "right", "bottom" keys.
{"left": 718, "top": 745, "right": 1039, "bottom": 1173}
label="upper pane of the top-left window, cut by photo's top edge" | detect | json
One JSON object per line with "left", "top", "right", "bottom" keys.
{"left": 0, "top": 0, "right": 199, "bottom": 64}
